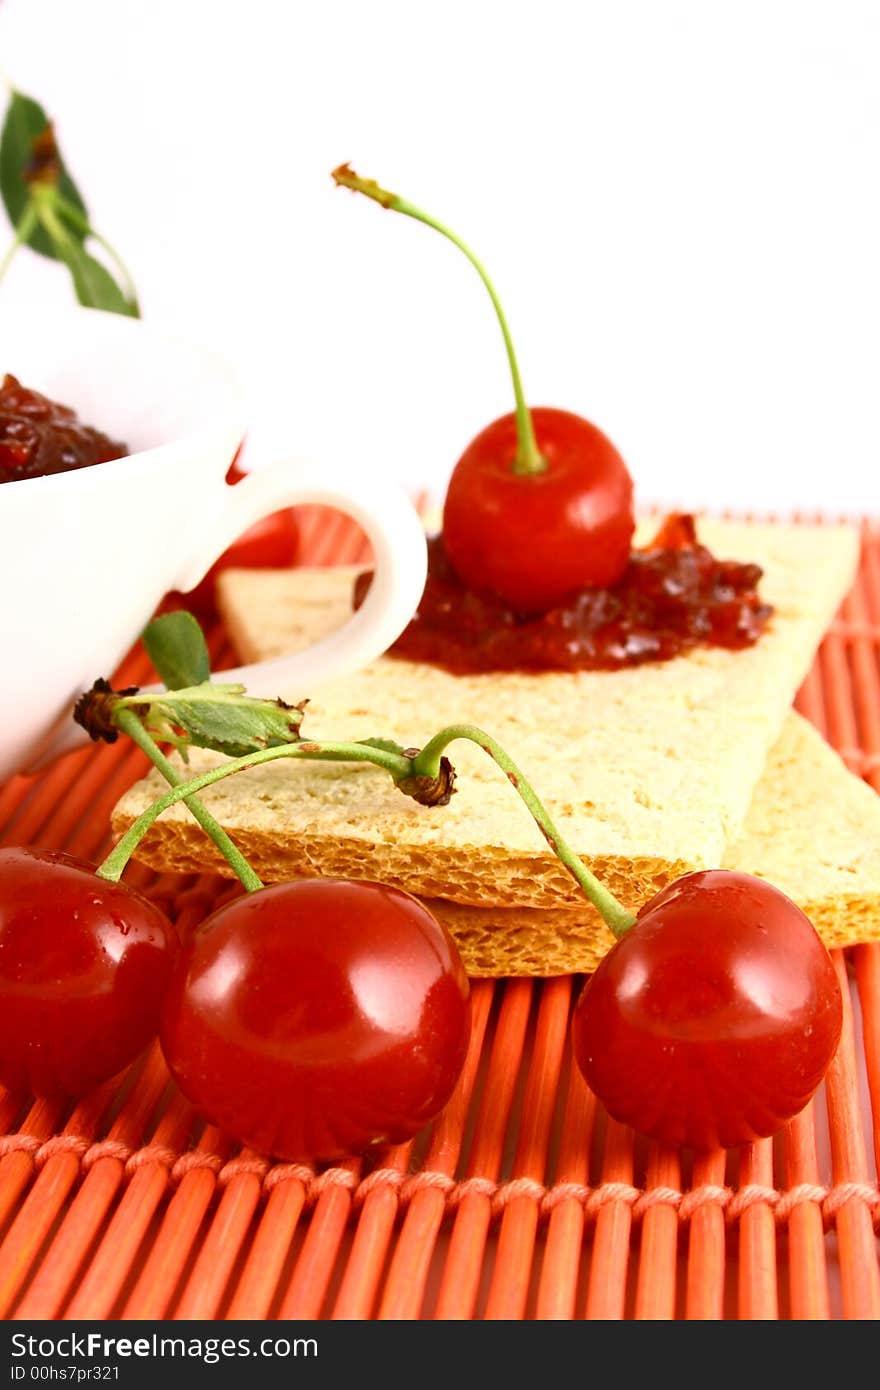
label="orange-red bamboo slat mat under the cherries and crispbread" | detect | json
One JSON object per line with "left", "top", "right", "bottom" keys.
{"left": 0, "top": 509, "right": 880, "bottom": 1321}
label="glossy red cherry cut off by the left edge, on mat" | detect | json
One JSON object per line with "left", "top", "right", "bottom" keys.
{"left": 0, "top": 848, "right": 178, "bottom": 1097}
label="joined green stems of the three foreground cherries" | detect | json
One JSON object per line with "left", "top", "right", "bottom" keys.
{"left": 99, "top": 712, "right": 635, "bottom": 937}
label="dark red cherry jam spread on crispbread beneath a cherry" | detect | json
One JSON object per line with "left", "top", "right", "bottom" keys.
{"left": 355, "top": 513, "right": 773, "bottom": 676}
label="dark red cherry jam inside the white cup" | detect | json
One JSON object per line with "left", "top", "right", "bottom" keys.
{"left": 0, "top": 374, "right": 128, "bottom": 482}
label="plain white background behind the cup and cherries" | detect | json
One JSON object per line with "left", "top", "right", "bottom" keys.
{"left": 0, "top": 0, "right": 880, "bottom": 514}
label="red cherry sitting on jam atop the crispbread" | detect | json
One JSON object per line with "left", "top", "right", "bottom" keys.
{"left": 443, "top": 406, "right": 635, "bottom": 613}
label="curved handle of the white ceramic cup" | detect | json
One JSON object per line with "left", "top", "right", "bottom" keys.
{"left": 177, "top": 459, "right": 427, "bottom": 698}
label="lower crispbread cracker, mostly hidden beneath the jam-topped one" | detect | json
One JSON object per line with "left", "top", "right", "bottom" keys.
{"left": 425, "top": 714, "right": 880, "bottom": 976}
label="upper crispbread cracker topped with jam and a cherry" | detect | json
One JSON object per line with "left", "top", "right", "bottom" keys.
{"left": 114, "top": 520, "right": 858, "bottom": 909}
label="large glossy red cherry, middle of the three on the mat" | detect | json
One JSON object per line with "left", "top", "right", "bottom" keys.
{"left": 161, "top": 878, "right": 470, "bottom": 1161}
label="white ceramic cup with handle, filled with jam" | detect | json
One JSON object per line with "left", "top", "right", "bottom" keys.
{"left": 0, "top": 309, "right": 425, "bottom": 780}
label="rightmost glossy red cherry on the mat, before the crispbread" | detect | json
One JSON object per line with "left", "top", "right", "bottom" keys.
{"left": 571, "top": 870, "right": 842, "bottom": 1150}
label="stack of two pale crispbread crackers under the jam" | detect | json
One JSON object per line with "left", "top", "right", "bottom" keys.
{"left": 113, "top": 518, "right": 880, "bottom": 976}
